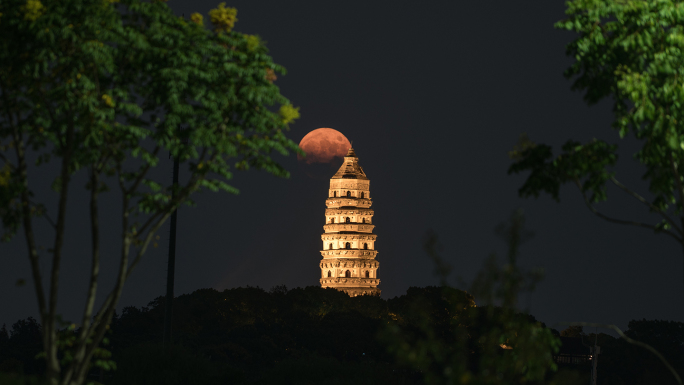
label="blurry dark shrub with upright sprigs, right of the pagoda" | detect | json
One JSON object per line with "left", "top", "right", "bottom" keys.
{"left": 384, "top": 211, "right": 560, "bottom": 384}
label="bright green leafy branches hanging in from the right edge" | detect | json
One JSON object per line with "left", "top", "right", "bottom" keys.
{"left": 508, "top": 0, "right": 684, "bottom": 304}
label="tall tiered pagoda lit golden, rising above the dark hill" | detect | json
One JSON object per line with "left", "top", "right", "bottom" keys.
{"left": 321, "top": 148, "right": 380, "bottom": 297}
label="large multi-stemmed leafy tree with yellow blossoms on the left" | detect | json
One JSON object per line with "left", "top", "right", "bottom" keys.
{"left": 0, "top": 0, "right": 301, "bottom": 384}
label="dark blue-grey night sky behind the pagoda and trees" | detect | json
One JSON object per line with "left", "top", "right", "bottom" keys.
{"left": 0, "top": 0, "right": 684, "bottom": 329}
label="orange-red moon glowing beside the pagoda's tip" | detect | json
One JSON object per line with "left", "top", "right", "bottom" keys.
{"left": 297, "top": 128, "right": 351, "bottom": 164}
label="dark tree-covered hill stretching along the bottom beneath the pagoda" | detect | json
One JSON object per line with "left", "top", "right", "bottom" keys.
{"left": 0, "top": 287, "right": 684, "bottom": 385}
